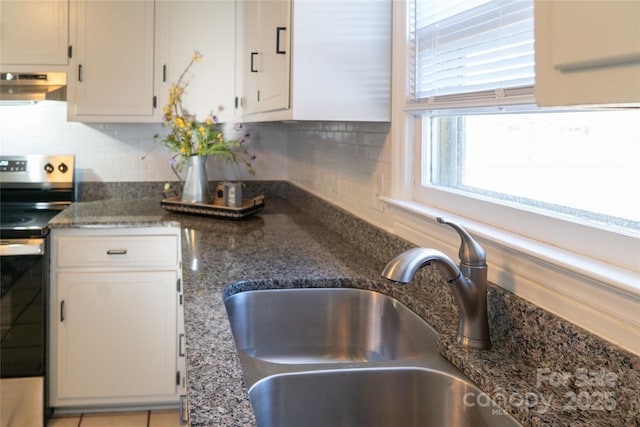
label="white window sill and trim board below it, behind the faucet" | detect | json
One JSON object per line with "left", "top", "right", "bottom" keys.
{"left": 380, "top": 197, "right": 640, "bottom": 354}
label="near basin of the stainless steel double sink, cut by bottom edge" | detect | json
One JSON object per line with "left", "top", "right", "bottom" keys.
{"left": 249, "top": 368, "right": 517, "bottom": 427}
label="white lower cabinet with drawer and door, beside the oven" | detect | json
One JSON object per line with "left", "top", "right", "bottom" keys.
{"left": 49, "top": 228, "right": 185, "bottom": 409}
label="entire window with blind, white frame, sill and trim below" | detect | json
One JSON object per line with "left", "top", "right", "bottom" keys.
{"left": 382, "top": 0, "right": 640, "bottom": 354}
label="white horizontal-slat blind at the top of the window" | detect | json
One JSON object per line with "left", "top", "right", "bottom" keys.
{"left": 409, "top": 0, "right": 535, "bottom": 109}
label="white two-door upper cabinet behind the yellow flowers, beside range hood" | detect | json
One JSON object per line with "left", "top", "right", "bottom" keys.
{"left": 68, "top": 0, "right": 236, "bottom": 122}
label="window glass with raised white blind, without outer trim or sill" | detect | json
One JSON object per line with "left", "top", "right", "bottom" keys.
{"left": 405, "top": 0, "right": 640, "bottom": 262}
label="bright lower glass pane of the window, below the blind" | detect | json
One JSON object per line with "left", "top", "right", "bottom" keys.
{"left": 421, "top": 110, "right": 640, "bottom": 231}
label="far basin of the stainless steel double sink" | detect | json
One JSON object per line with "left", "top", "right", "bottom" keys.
{"left": 225, "top": 288, "right": 437, "bottom": 364}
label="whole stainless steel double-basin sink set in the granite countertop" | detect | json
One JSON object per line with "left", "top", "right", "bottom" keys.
{"left": 225, "top": 288, "right": 519, "bottom": 427}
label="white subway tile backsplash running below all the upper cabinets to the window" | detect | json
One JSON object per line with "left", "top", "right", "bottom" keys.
{"left": 0, "top": 103, "right": 391, "bottom": 226}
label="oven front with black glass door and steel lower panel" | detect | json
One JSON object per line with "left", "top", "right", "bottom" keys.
{"left": 0, "top": 239, "right": 46, "bottom": 427}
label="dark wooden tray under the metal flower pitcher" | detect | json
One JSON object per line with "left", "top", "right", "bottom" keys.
{"left": 160, "top": 196, "right": 264, "bottom": 219}
